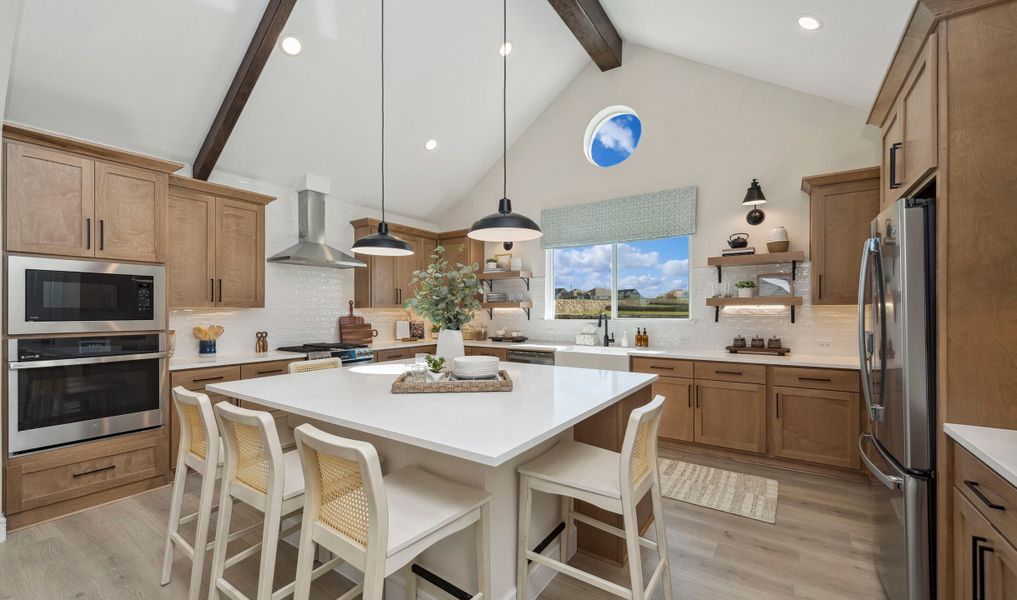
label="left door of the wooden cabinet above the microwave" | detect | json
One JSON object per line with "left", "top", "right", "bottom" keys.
{"left": 4, "top": 142, "right": 96, "bottom": 256}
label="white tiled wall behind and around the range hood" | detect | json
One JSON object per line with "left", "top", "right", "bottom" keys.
{"left": 170, "top": 166, "right": 437, "bottom": 357}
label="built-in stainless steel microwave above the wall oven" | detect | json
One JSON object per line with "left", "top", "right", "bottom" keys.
{"left": 7, "top": 256, "right": 166, "bottom": 336}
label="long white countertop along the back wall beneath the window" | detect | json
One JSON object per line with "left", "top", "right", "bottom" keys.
{"left": 371, "top": 340, "right": 858, "bottom": 370}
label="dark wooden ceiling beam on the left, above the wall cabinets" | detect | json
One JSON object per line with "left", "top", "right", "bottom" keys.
{"left": 192, "top": 0, "right": 297, "bottom": 180}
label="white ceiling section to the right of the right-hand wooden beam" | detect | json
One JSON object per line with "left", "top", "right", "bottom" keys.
{"left": 601, "top": 0, "right": 915, "bottom": 110}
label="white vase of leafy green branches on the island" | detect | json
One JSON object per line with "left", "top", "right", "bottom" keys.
{"left": 403, "top": 246, "right": 483, "bottom": 360}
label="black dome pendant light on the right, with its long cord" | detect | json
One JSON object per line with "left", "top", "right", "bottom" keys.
{"left": 467, "top": 0, "right": 544, "bottom": 243}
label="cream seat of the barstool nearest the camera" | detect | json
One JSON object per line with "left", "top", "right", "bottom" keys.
{"left": 382, "top": 467, "right": 491, "bottom": 556}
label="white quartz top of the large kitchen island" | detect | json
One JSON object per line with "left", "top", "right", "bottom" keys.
{"left": 207, "top": 362, "right": 657, "bottom": 467}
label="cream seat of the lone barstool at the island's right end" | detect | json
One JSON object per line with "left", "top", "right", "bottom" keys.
{"left": 519, "top": 439, "right": 621, "bottom": 498}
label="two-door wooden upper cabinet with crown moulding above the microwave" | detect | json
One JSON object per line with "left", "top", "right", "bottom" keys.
{"left": 3, "top": 125, "right": 181, "bottom": 262}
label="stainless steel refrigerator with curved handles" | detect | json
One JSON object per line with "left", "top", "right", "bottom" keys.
{"left": 858, "top": 198, "right": 936, "bottom": 600}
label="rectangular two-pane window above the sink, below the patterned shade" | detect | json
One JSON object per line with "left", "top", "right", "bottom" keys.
{"left": 546, "top": 236, "right": 689, "bottom": 319}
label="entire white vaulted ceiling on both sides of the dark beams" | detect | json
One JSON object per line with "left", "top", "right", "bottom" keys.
{"left": 5, "top": 0, "right": 914, "bottom": 222}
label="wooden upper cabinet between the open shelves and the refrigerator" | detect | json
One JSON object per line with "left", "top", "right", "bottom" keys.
{"left": 801, "top": 167, "right": 880, "bottom": 304}
